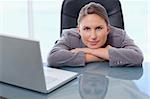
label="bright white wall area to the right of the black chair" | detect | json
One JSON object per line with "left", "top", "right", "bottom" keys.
{"left": 120, "top": 0, "right": 150, "bottom": 61}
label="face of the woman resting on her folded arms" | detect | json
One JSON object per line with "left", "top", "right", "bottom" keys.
{"left": 78, "top": 14, "right": 109, "bottom": 49}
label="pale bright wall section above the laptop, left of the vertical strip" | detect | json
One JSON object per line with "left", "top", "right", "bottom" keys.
{"left": 0, "top": 0, "right": 28, "bottom": 37}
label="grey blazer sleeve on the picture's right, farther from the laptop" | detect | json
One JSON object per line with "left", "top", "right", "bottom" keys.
{"left": 109, "top": 31, "right": 143, "bottom": 66}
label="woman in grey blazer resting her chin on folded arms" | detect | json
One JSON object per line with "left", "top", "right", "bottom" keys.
{"left": 48, "top": 2, "right": 143, "bottom": 67}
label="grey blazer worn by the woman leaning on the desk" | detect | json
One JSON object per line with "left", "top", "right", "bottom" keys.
{"left": 48, "top": 26, "right": 143, "bottom": 67}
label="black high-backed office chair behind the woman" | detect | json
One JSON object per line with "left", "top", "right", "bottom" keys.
{"left": 60, "top": 0, "right": 124, "bottom": 36}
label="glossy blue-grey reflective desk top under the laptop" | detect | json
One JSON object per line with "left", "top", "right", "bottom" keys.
{"left": 0, "top": 62, "right": 150, "bottom": 99}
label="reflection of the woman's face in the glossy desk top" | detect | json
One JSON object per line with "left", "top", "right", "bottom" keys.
{"left": 79, "top": 73, "right": 108, "bottom": 99}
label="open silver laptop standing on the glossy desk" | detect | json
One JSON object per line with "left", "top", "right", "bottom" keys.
{"left": 0, "top": 34, "right": 78, "bottom": 93}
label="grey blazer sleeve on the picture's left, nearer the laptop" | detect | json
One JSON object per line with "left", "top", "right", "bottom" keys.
{"left": 48, "top": 31, "right": 85, "bottom": 67}
